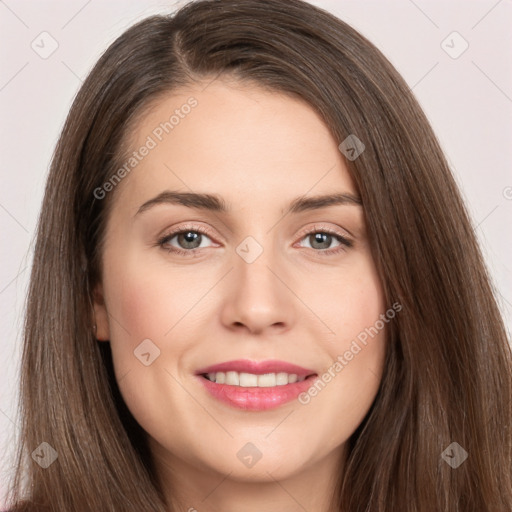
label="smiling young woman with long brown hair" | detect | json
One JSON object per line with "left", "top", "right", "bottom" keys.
{"left": 5, "top": 0, "right": 512, "bottom": 512}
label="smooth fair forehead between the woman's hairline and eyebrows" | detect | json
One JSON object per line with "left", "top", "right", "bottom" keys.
{"left": 110, "top": 80, "right": 356, "bottom": 215}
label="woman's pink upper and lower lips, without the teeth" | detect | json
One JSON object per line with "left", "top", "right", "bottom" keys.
{"left": 197, "top": 360, "right": 317, "bottom": 411}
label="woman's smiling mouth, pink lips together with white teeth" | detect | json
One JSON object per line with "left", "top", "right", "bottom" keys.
{"left": 196, "top": 360, "right": 318, "bottom": 411}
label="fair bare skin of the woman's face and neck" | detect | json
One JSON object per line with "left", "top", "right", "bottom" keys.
{"left": 94, "top": 78, "right": 386, "bottom": 512}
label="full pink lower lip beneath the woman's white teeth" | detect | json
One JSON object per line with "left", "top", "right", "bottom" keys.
{"left": 198, "top": 375, "right": 317, "bottom": 411}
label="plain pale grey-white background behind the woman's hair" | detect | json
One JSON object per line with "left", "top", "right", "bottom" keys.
{"left": 0, "top": 0, "right": 512, "bottom": 506}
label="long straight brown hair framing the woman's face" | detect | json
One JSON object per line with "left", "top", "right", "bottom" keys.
{"left": 5, "top": 0, "right": 512, "bottom": 512}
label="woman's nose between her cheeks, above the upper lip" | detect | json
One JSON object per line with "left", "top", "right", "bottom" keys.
{"left": 221, "top": 241, "right": 297, "bottom": 335}
